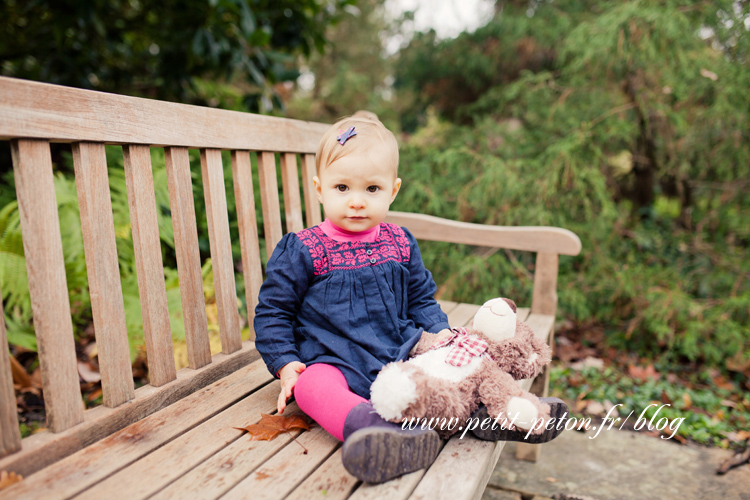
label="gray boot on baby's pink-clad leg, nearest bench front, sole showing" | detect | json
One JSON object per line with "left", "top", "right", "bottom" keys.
{"left": 341, "top": 402, "right": 440, "bottom": 483}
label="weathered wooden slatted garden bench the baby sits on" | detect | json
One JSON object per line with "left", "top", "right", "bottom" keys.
{"left": 0, "top": 78, "right": 580, "bottom": 500}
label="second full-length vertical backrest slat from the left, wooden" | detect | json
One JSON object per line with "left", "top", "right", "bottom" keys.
{"left": 73, "top": 143, "right": 135, "bottom": 408}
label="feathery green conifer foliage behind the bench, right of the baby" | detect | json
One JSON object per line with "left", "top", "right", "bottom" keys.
{"left": 394, "top": 1, "right": 750, "bottom": 367}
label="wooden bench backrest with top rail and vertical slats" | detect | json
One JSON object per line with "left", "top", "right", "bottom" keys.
{"left": 0, "top": 77, "right": 328, "bottom": 457}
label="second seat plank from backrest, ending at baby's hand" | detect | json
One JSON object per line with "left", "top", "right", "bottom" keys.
{"left": 76, "top": 381, "right": 280, "bottom": 500}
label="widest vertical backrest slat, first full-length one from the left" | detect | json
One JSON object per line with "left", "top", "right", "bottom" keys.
{"left": 11, "top": 139, "right": 83, "bottom": 432}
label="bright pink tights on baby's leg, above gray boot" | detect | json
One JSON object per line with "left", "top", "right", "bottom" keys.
{"left": 294, "top": 363, "right": 367, "bottom": 441}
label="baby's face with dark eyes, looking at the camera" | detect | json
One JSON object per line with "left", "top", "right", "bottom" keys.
{"left": 314, "top": 148, "right": 401, "bottom": 232}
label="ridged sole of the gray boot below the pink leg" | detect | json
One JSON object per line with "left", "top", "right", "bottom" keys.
{"left": 341, "top": 427, "right": 440, "bottom": 483}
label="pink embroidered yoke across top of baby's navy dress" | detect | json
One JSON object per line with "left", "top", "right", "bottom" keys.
{"left": 297, "top": 223, "right": 411, "bottom": 276}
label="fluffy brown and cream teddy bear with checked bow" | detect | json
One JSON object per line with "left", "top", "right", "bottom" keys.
{"left": 370, "top": 298, "right": 567, "bottom": 442}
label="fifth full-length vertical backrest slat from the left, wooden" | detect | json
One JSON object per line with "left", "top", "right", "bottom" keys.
{"left": 201, "top": 149, "right": 242, "bottom": 354}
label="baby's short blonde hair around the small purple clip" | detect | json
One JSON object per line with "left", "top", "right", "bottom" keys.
{"left": 315, "top": 115, "right": 398, "bottom": 175}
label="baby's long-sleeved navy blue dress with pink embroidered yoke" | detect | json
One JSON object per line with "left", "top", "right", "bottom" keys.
{"left": 254, "top": 223, "right": 450, "bottom": 399}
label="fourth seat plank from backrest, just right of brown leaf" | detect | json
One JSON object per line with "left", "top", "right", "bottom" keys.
{"left": 222, "top": 426, "right": 339, "bottom": 500}
